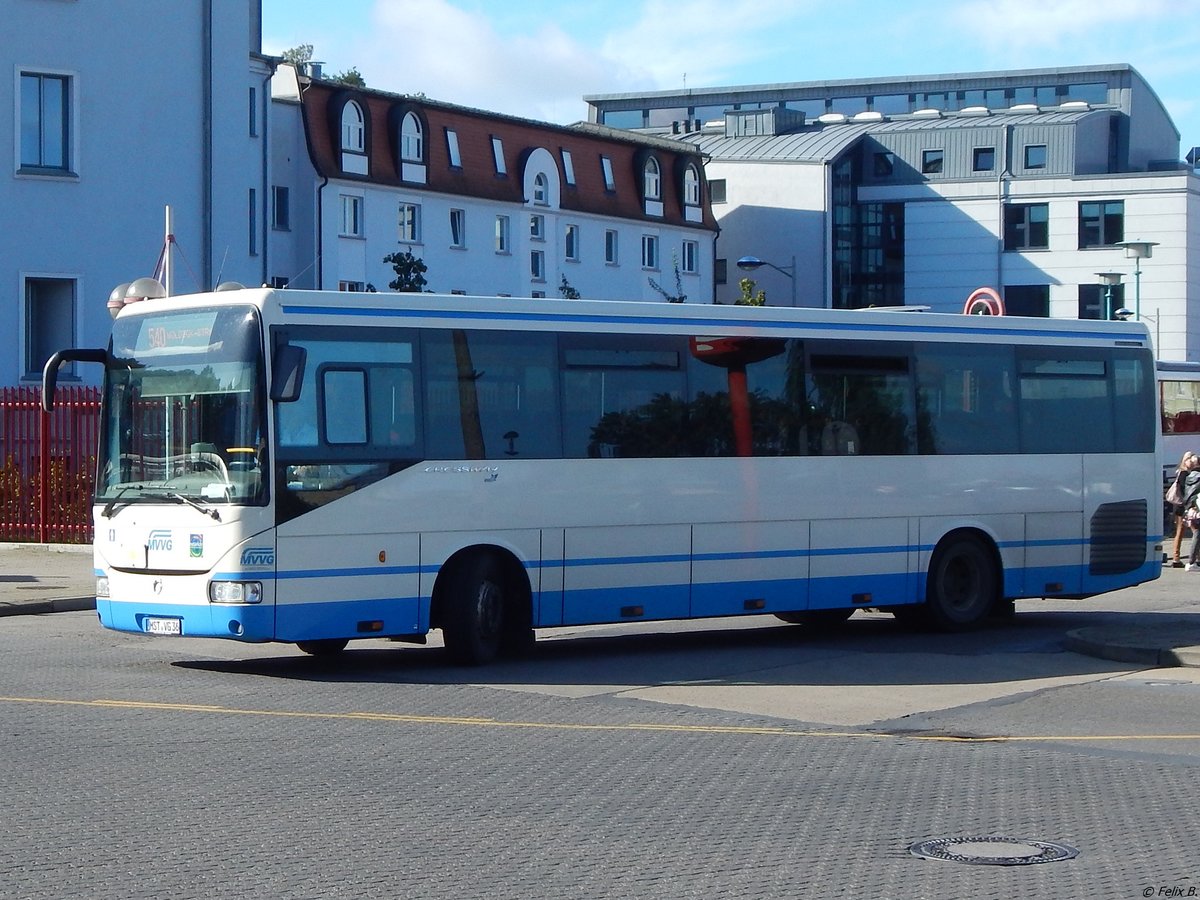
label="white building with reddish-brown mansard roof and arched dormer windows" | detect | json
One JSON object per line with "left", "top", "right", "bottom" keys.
{"left": 270, "top": 65, "right": 716, "bottom": 302}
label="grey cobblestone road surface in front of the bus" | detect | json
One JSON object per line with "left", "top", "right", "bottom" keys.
{"left": 0, "top": 612, "right": 1200, "bottom": 900}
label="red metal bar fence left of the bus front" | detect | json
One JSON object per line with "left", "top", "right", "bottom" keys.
{"left": 0, "top": 385, "right": 100, "bottom": 544}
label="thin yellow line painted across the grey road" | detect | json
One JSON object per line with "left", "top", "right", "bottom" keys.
{"left": 0, "top": 697, "right": 1200, "bottom": 744}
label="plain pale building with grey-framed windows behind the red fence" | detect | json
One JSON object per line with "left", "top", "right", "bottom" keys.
{"left": 0, "top": 0, "right": 272, "bottom": 384}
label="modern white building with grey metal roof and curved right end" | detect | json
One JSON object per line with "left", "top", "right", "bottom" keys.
{"left": 587, "top": 65, "right": 1200, "bottom": 360}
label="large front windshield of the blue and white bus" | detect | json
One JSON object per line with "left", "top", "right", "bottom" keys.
{"left": 96, "top": 306, "right": 268, "bottom": 514}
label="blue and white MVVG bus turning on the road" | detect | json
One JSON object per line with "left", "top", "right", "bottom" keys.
{"left": 44, "top": 289, "right": 1162, "bottom": 664}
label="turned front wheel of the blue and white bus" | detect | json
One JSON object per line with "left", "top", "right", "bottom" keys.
{"left": 440, "top": 553, "right": 509, "bottom": 666}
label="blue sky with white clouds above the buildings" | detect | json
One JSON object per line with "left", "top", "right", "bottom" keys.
{"left": 263, "top": 0, "right": 1200, "bottom": 157}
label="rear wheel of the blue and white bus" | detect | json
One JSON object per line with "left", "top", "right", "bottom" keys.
{"left": 920, "top": 534, "right": 1000, "bottom": 631}
